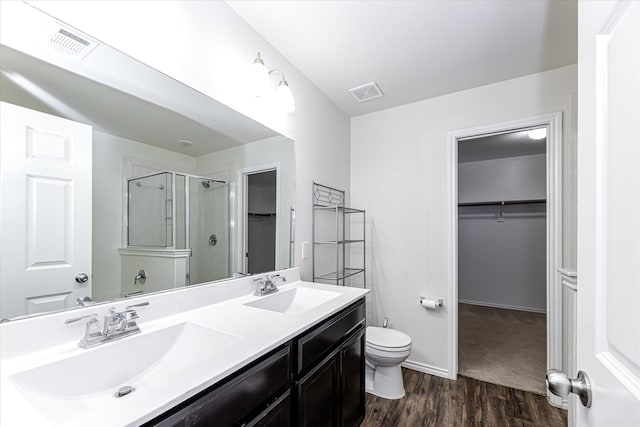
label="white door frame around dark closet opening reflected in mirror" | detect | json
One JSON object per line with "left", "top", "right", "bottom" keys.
{"left": 236, "top": 162, "right": 281, "bottom": 273}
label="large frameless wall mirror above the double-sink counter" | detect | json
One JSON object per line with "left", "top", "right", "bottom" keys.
{"left": 0, "top": 2, "right": 295, "bottom": 319}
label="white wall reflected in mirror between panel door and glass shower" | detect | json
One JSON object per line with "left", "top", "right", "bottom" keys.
{"left": 92, "top": 131, "right": 196, "bottom": 301}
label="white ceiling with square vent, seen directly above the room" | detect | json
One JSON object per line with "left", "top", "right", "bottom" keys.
{"left": 228, "top": 0, "right": 577, "bottom": 116}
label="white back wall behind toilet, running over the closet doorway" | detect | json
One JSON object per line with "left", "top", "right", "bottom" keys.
{"left": 351, "top": 66, "right": 576, "bottom": 375}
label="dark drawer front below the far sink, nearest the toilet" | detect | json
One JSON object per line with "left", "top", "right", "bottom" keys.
{"left": 294, "top": 299, "right": 365, "bottom": 374}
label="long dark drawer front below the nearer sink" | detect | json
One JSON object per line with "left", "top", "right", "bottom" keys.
{"left": 147, "top": 345, "right": 291, "bottom": 427}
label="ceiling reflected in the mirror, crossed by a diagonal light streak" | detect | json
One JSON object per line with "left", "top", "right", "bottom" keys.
{"left": 0, "top": 45, "right": 239, "bottom": 156}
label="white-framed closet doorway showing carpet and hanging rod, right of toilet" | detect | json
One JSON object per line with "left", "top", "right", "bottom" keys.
{"left": 450, "top": 115, "right": 562, "bottom": 403}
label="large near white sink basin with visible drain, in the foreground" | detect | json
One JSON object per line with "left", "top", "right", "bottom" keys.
{"left": 10, "top": 323, "right": 242, "bottom": 399}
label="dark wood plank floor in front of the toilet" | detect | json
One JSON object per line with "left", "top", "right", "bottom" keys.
{"left": 362, "top": 369, "right": 567, "bottom": 427}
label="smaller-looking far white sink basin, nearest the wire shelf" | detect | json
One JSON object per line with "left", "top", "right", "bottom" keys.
{"left": 245, "top": 288, "right": 342, "bottom": 314}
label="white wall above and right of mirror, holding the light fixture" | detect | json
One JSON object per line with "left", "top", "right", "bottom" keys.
{"left": 30, "top": 1, "right": 350, "bottom": 279}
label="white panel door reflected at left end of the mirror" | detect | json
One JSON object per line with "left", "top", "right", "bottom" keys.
{"left": 0, "top": 102, "right": 92, "bottom": 318}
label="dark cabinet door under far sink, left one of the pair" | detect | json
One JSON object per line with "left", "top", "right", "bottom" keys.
{"left": 297, "top": 348, "right": 340, "bottom": 427}
